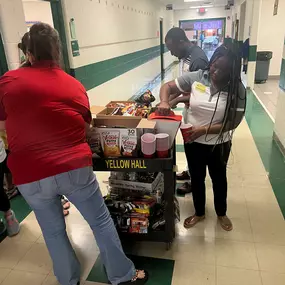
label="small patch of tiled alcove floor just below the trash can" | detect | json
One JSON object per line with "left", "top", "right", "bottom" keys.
{"left": 254, "top": 79, "right": 280, "bottom": 120}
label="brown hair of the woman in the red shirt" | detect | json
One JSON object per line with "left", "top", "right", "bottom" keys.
{"left": 28, "top": 23, "right": 61, "bottom": 65}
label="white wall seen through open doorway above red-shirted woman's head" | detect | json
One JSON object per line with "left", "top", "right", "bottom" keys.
{"left": 23, "top": 0, "right": 53, "bottom": 27}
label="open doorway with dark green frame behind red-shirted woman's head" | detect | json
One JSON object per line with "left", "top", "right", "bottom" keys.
{"left": 22, "top": 0, "right": 70, "bottom": 74}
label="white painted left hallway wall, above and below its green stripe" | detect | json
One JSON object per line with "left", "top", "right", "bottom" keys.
{"left": 63, "top": 0, "right": 173, "bottom": 105}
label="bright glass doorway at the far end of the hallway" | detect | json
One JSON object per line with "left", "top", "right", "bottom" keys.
{"left": 179, "top": 18, "right": 226, "bottom": 59}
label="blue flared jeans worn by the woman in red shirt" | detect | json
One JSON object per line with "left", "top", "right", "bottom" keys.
{"left": 18, "top": 167, "right": 135, "bottom": 285}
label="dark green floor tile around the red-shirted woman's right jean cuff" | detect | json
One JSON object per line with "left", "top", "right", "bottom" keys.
{"left": 87, "top": 255, "right": 175, "bottom": 285}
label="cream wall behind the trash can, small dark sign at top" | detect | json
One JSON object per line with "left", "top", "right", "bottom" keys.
{"left": 257, "top": 0, "right": 285, "bottom": 76}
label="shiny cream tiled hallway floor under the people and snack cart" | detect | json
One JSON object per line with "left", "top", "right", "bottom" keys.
{"left": 0, "top": 67, "right": 285, "bottom": 285}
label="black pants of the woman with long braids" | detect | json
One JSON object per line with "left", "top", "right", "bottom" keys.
{"left": 185, "top": 142, "right": 232, "bottom": 216}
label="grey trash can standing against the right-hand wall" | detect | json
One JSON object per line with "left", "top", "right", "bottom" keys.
{"left": 255, "top": 51, "right": 272, "bottom": 83}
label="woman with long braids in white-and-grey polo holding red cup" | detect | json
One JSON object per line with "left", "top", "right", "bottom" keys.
{"left": 159, "top": 46, "right": 246, "bottom": 231}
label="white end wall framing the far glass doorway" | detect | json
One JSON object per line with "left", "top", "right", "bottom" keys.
{"left": 174, "top": 7, "right": 232, "bottom": 37}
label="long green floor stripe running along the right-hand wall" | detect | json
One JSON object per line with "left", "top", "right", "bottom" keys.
{"left": 246, "top": 90, "right": 285, "bottom": 218}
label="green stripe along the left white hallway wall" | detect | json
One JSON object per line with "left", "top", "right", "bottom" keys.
{"left": 71, "top": 46, "right": 168, "bottom": 90}
